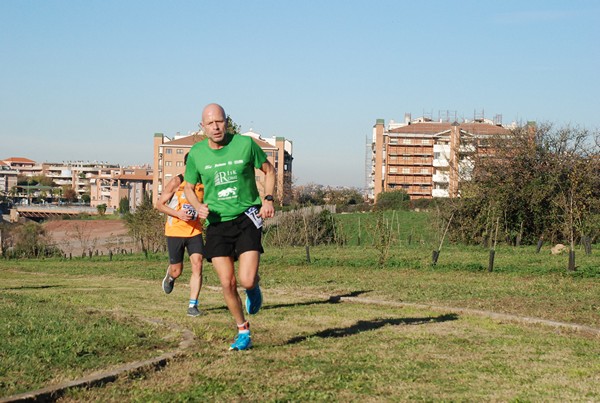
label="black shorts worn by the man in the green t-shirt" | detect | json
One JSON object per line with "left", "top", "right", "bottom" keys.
{"left": 204, "top": 213, "right": 264, "bottom": 262}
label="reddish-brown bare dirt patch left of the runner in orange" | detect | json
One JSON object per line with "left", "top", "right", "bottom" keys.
{"left": 43, "top": 220, "right": 135, "bottom": 256}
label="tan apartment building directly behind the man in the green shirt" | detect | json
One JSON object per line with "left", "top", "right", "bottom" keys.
{"left": 152, "top": 130, "right": 293, "bottom": 208}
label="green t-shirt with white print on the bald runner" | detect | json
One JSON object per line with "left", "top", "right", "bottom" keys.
{"left": 185, "top": 134, "right": 267, "bottom": 224}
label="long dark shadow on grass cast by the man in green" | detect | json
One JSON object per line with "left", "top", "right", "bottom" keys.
{"left": 285, "top": 313, "right": 458, "bottom": 344}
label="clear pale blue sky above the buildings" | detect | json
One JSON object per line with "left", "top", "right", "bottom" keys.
{"left": 0, "top": 0, "right": 600, "bottom": 187}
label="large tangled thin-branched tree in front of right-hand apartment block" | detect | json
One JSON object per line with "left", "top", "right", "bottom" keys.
{"left": 446, "top": 123, "right": 600, "bottom": 249}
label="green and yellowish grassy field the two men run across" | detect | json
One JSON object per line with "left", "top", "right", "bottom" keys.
{"left": 0, "top": 237, "right": 600, "bottom": 402}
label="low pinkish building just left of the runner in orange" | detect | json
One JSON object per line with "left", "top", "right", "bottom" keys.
{"left": 90, "top": 165, "right": 153, "bottom": 211}
